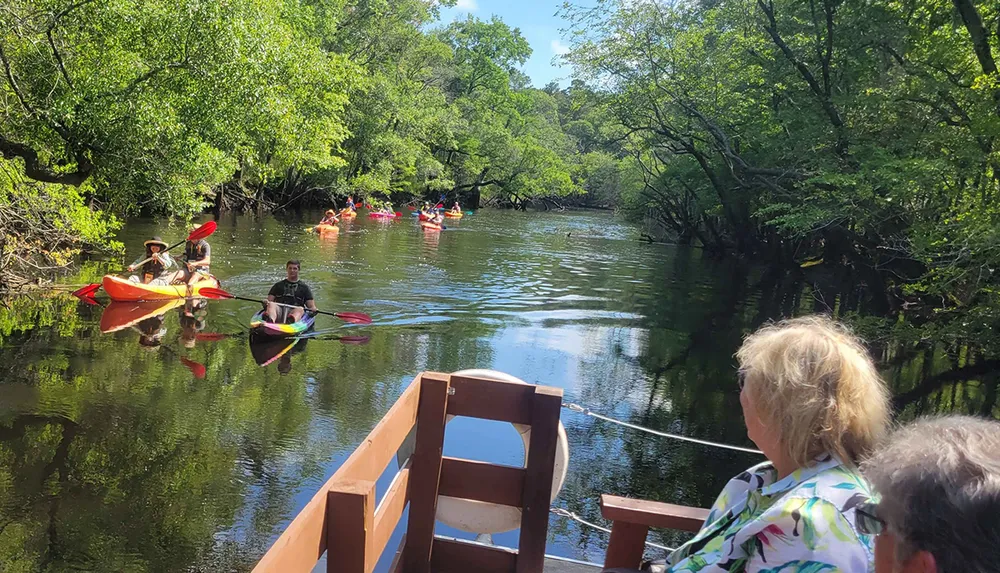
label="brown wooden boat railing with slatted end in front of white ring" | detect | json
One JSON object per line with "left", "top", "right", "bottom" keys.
{"left": 254, "top": 372, "right": 562, "bottom": 573}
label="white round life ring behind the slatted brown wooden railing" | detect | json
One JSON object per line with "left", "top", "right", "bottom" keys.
{"left": 397, "top": 369, "right": 569, "bottom": 533}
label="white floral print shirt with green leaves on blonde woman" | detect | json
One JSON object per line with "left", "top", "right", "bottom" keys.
{"left": 667, "top": 455, "right": 875, "bottom": 573}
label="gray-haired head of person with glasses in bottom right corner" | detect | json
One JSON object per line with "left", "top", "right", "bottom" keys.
{"left": 863, "top": 416, "right": 1000, "bottom": 573}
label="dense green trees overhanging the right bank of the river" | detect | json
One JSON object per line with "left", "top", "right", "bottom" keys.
{"left": 565, "top": 0, "right": 1000, "bottom": 318}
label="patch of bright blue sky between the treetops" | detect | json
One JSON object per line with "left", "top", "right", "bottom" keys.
{"left": 441, "top": 0, "right": 570, "bottom": 88}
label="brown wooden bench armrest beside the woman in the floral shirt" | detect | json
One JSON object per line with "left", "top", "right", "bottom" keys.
{"left": 601, "top": 494, "right": 708, "bottom": 569}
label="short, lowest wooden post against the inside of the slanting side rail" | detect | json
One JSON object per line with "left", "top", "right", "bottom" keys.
{"left": 326, "top": 480, "right": 378, "bottom": 573}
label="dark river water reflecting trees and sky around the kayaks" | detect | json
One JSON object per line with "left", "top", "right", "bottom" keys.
{"left": 0, "top": 211, "right": 997, "bottom": 571}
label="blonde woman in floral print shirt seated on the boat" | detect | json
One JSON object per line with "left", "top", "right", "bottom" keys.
{"left": 608, "top": 317, "right": 889, "bottom": 573}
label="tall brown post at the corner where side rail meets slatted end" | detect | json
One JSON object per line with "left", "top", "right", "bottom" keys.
{"left": 403, "top": 372, "right": 450, "bottom": 573}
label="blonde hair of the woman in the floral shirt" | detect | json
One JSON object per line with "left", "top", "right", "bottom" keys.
{"left": 736, "top": 316, "right": 889, "bottom": 467}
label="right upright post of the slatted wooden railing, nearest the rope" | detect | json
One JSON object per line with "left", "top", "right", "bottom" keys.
{"left": 516, "top": 386, "right": 563, "bottom": 573}
